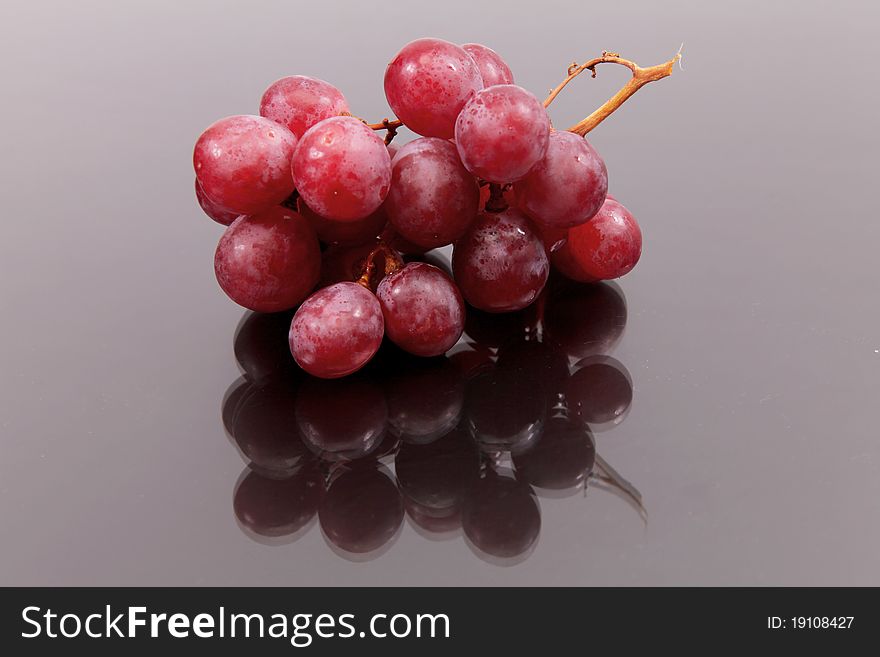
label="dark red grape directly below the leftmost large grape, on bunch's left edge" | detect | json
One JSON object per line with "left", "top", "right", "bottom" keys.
{"left": 214, "top": 206, "right": 321, "bottom": 313}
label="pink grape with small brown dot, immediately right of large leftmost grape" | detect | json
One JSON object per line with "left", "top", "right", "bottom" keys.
{"left": 292, "top": 116, "right": 391, "bottom": 221}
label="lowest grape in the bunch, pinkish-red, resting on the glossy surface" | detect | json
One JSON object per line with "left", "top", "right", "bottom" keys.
{"left": 289, "top": 282, "right": 384, "bottom": 379}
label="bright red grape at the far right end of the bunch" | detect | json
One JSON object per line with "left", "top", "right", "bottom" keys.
{"left": 553, "top": 200, "right": 642, "bottom": 282}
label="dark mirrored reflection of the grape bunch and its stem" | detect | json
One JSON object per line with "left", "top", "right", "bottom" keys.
{"left": 223, "top": 278, "right": 638, "bottom": 564}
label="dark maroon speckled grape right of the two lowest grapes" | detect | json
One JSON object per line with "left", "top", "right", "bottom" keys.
{"left": 452, "top": 209, "right": 550, "bottom": 312}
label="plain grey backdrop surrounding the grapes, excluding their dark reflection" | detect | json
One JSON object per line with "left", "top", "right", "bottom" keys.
{"left": 0, "top": 0, "right": 880, "bottom": 585}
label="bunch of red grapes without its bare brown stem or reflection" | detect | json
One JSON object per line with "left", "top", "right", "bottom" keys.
{"left": 193, "top": 38, "right": 642, "bottom": 378}
